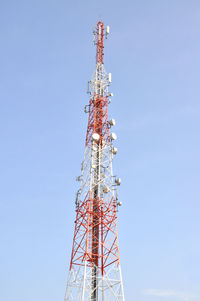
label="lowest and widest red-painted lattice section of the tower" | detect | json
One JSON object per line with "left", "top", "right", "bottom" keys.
{"left": 70, "top": 193, "right": 119, "bottom": 274}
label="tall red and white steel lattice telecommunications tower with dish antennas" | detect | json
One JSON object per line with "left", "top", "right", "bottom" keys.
{"left": 65, "top": 21, "right": 125, "bottom": 301}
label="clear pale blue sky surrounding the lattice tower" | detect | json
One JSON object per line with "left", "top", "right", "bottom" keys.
{"left": 0, "top": 0, "right": 200, "bottom": 301}
